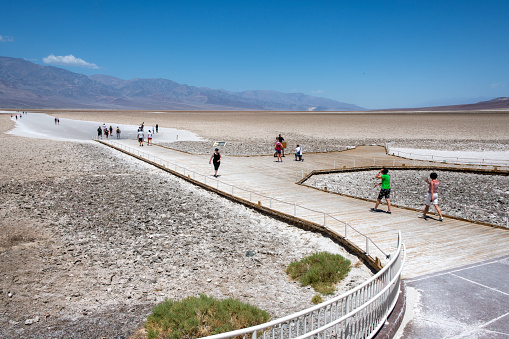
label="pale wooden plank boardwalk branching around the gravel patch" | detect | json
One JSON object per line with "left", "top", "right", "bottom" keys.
{"left": 99, "top": 140, "right": 509, "bottom": 278}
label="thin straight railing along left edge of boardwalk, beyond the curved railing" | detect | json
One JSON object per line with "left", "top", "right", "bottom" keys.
{"left": 102, "top": 140, "right": 388, "bottom": 264}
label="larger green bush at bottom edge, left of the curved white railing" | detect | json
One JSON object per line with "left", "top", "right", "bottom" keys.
{"left": 145, "top": 294, "right": 270, "bottom": 339}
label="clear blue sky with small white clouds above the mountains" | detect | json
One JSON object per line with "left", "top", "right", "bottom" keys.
{"left": 0, "top": 0, "right": 509, "bottom": 109}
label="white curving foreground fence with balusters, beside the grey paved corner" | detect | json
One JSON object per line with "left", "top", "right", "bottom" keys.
{"left": 200, "top": 232, "right": 405, "bottom": 339}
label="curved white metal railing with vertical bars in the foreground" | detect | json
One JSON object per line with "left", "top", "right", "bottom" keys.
{"left": 200, "top": 232, "right": 405, "bottom": 339}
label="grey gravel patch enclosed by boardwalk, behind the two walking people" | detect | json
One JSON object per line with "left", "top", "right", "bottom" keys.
{"left": 305, "top": 170, "right": 509, "bottom": 226}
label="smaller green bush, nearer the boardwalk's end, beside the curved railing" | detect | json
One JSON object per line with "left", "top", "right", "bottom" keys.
{"left": 286, "top": 252, "right": 350, "bottom": 294}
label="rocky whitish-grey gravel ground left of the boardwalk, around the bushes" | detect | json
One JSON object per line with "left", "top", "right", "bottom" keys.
{"left": 0, "top": 115, "right": 371, "bottom": 338}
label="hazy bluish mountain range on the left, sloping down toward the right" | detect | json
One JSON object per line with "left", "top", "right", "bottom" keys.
{"left": 0, "top": 57, "right": 365, "bottom": 111}
